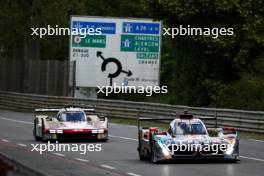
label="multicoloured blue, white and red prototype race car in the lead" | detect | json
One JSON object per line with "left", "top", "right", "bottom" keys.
{"left": 138, "top": 114, "right": 239, "bottom": 163}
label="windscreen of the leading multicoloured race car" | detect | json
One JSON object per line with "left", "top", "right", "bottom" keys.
{"left": 173, "top": 122, "right": 206, "bottom": 135}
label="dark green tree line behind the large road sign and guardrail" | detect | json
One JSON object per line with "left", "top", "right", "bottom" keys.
{"left": 0, "top": 0, "right": 264, "bottom": 110}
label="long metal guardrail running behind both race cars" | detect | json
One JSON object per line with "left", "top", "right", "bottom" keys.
{"left": 0, "top": 91, "right": 264, "bottom": 133}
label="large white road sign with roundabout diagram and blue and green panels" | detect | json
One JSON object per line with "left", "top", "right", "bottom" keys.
{"left": 70, "top": 16, "right": 161, "bottom": 87}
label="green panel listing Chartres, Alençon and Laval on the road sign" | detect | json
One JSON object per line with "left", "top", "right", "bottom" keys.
{"left": 120, "top": 35, "right": 159, "bottom": 53}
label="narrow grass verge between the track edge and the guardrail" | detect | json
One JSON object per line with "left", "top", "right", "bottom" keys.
{"left": 109, "top": 118, "right": 264, "bottom": 140}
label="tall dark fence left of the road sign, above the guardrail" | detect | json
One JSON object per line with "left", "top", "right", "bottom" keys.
{"left": 0, "top": 58, "right": 69, "bottom": 96}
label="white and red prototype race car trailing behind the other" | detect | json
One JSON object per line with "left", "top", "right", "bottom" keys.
{"left": 33, "top": 106, "right": 108, "bottom": 141}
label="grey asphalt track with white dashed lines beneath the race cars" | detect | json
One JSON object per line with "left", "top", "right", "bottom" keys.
{"left": 0, "top": 110, "right": 264, "bottom": 176}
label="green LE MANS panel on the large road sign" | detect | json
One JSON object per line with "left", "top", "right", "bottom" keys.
{"left": 72, "top": 35, "right": 106, "bottom": 48}
